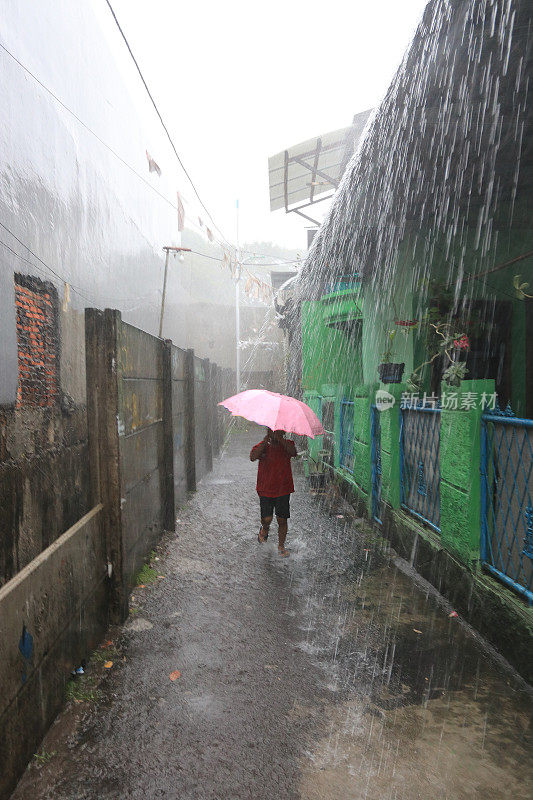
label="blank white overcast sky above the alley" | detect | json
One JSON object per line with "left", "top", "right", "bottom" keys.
{"left": 104, "top": 0, "right": 427, "bottom": 248}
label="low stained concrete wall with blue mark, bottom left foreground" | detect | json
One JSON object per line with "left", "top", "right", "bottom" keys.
{"left": 0, "top": 505, "right": 107, "bottom": 798}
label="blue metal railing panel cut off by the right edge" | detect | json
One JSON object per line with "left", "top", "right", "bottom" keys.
{"left": 481, "top": 406, "right": 533, "bottom": 605}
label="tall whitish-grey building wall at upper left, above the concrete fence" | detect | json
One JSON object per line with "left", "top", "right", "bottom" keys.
{"left": 0, "top": 0, "right": 282, "bottom": 403}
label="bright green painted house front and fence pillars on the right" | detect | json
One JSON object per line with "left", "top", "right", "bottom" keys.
{"left": 302, "top": 209, "right": 533, "bottom": 580}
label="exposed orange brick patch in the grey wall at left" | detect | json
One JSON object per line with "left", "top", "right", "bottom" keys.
{"left": 15, "top": 276, "right": 59, "bottom": 408}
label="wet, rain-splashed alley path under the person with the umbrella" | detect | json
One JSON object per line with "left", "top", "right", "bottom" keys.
{"left": 13, "top": 429, "right": 533, "bottom": 800}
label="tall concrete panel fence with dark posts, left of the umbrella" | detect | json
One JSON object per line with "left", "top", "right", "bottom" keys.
{"left": 86, "top": 309, "right": 227, "bottom": 608}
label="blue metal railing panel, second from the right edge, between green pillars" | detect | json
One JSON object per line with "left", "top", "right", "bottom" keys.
{"left": 400, "top": 404, "right": 441, "bottom": 533}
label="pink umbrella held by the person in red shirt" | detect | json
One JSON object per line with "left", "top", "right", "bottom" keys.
{"left": 219, "top": 389, "right": 325, "bottom": 439}
